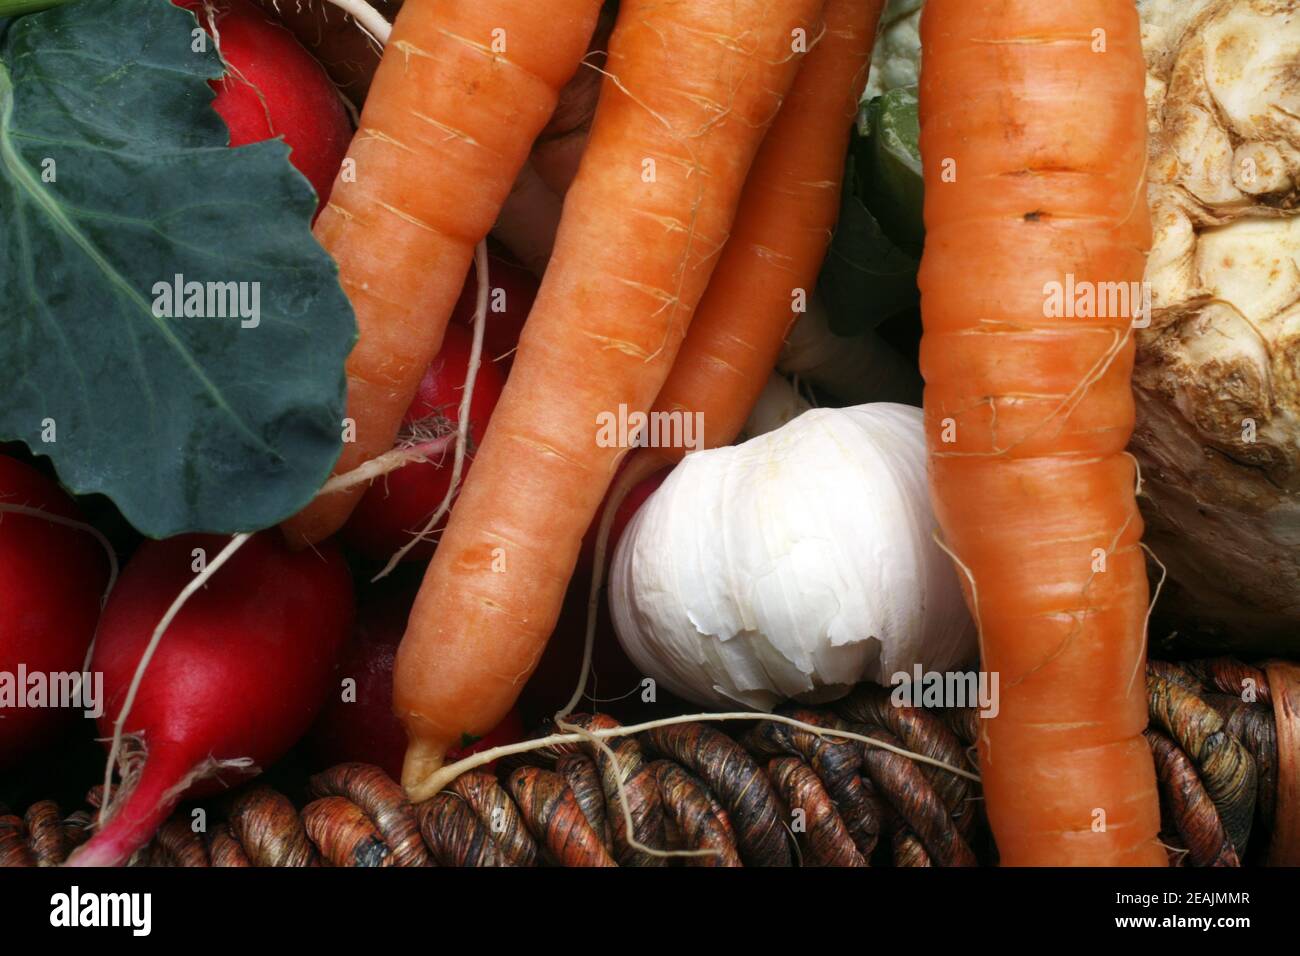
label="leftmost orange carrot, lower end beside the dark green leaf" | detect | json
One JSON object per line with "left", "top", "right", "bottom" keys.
{"left": 283, "top": 0, "right": 601, "bottom": 544}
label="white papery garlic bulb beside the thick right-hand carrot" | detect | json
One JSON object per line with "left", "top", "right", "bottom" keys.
{"left": 610, "top": 403, "right": 976, "bottom": 710}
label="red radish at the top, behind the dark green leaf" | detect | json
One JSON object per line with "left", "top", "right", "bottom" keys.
{"left": 173, "top": 0, "right": 352, "bottom": 212}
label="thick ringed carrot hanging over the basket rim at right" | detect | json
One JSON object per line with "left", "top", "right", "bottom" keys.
{"left": 919, "top": 0, "right": 1165, "bottom": 866}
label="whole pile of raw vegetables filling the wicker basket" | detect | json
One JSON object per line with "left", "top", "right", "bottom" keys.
{"left": 0, "top": 0, "right": 1300, "bottom": 865}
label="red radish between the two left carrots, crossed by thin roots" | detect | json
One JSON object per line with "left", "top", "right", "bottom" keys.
{"left": 343, "top": 323, "right": 506, "bottom": 561}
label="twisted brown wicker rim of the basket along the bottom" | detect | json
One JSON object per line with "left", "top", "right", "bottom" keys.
{"left": 0, "top": 658, "right": 1297, "bottom": 866}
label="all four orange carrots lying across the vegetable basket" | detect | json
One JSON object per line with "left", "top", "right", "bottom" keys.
{"left": 286, "top": 0, "right": 1160, "bottom": 862}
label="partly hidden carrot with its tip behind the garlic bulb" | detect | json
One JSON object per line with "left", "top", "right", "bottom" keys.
{"left": 650, "top": 0, "right": 884, "bottom": 467}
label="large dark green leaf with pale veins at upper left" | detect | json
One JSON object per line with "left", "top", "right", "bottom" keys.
{"left": 0, "top": 0, "right": 355, "bottom": 537}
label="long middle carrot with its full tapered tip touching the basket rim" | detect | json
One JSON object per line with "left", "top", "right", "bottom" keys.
{"left": 394, "top": 0, "right": 823, "bottom": 800}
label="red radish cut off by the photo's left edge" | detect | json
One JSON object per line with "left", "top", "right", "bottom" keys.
{"left": 0, "top": 457, "right": 108, "bottom": 767}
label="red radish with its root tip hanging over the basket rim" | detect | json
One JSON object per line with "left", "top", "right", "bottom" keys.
{"left": 70, "top": 531, "right": 354, "bottom": 866}
